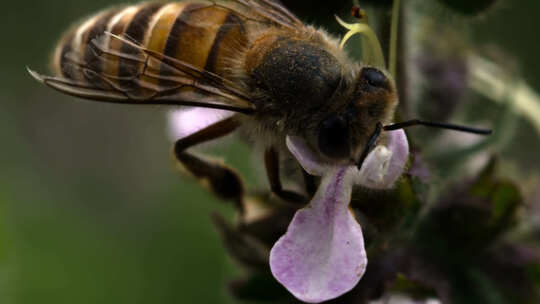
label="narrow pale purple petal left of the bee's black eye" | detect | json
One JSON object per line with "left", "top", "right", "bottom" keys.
{"left": 285, "top": 135, "right": 329, "bottom": 176}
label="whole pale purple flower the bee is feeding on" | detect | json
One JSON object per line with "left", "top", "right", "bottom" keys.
{"left": 270, "top": 130, "right": 409, "bottom": 303}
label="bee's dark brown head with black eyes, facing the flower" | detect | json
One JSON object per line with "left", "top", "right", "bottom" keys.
{"left": 317, "top": 67, "right": 397, "bottom": 163}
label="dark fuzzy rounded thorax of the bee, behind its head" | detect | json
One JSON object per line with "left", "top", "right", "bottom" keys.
{"left": 246, "top": 36, "right": 342, "bottom": 112}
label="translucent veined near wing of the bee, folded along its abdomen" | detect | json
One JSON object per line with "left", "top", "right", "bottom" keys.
{"left": 28, "top": 32, "right": 255, "bottom": 113}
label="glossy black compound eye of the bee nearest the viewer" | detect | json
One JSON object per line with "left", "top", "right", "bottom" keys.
{"left": 318, "top": 115, "right": 350, "bottom": 159}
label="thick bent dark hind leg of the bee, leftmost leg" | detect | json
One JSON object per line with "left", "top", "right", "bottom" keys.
{"left": 174, "top": 117, "right": 244, "bottom": 211}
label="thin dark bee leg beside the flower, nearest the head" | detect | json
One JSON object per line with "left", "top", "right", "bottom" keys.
{"left": 264, "top": 147, "right": 308, "bottom": 204}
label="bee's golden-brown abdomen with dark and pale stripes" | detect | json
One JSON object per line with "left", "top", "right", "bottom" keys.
{"left": 53, "top": 2, "right": 247, "bottom": 90}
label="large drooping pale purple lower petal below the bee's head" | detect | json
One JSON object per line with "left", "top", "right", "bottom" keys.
{"left": 270, "top": 167, "right": 367, "bottom": 303}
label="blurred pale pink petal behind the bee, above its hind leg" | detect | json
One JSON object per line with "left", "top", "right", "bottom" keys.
{"left": 168, "top": 108, "right": 235, "bottom": 141}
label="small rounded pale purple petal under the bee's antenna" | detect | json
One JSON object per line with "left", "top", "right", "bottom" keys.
{"left": 356, "top": 130, "right": 409, "bottom": 189}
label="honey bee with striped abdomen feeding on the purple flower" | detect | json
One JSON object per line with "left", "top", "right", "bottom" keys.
{"left": 30, "top": 0, "right": 490, "bottom": 202}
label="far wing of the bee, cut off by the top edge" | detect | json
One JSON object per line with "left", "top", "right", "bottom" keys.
{"left": 220, "top": 0, "right": 304, "bottom": 30}
